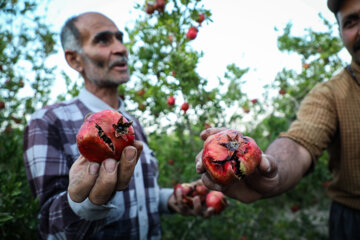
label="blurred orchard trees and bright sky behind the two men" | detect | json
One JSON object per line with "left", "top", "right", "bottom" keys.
{"left": 0, "top": 0, "right": 350, "bottom": 240}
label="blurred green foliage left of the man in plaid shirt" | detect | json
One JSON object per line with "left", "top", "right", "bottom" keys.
{"left": 0, "top": 0, "right": 55, "bottom": 239}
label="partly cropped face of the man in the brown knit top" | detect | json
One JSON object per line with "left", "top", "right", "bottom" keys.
{"left": 337, "top": 0, "right": 360, "bottom": 64}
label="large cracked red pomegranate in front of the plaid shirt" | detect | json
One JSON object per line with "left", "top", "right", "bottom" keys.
{"left": 76, "top": 109, "right": 135, "bottom": 163}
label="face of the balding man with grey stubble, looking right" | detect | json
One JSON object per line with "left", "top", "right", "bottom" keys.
{"left": 76, "top": 13, "right": 129, "bottom": 88}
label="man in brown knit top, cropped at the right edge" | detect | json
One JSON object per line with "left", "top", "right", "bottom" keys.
{"left": 196, "top": 0, "right": 360, "bottom": 240}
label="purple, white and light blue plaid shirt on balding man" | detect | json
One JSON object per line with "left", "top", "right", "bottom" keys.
{"left": 24, "top": 89, "right": 172, "bottom": 240}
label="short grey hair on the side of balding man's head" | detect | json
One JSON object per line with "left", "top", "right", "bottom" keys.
{"left": 60, "top": 16, "right": 82, "bottom": 53}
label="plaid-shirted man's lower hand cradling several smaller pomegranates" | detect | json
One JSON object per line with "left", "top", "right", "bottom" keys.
{"left": 168, "top": 180, "right": 215, "bottom": 218}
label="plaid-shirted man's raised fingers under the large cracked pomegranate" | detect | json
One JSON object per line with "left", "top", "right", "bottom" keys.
{"left": 68, "top": 141, "right": 143, "bottom": 205}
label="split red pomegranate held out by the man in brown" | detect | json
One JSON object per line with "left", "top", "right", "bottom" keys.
{"left": 202, "top": 129, "right": 262, "bottom": 184}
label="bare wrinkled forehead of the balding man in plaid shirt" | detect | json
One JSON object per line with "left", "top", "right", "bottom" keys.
{"left": 76, "top": 13, "right": 119, "bottom": 43}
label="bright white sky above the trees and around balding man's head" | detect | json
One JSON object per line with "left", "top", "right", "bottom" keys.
{"left": 42, "top": 0, "right": 349, "bottom": 101}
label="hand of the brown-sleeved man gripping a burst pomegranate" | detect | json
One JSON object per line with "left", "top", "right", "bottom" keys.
{"left": 195, "top": 128, "right": 279, "bottom": 203}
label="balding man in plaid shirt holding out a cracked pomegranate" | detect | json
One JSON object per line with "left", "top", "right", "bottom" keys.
{"left": 24, "top": 12, "right": 213, "bottom": 240}
